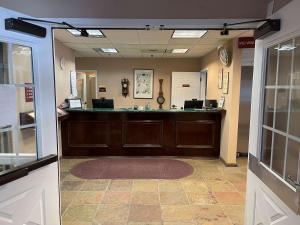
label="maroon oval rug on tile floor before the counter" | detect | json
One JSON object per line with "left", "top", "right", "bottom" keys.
{"left": 71, "top": 158, "right": 193, "bottom": 179}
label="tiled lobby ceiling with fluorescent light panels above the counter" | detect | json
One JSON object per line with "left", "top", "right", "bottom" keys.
{"left": 54, "top": 29, "right": 253, "bottom": 58}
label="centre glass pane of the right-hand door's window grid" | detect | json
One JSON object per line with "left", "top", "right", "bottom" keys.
{"left": 275, "top": 89, "right": 290, "bottom": 132}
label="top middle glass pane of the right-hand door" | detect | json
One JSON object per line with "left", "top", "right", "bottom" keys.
{"left": 277, "top": 40, "right": 293, "bottom": 85}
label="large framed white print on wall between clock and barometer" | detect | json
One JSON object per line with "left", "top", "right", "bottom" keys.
{"left": 133, "top": 69, "right": 154, "bottom": 99}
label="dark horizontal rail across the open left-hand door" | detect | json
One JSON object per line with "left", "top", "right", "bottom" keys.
{"left": 0, "top": 155, "right": 58, "bottom": 186}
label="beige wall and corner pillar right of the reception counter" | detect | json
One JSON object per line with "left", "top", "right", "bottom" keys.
{"left": 201, "top": 39, "right": 241, "bottom": 165}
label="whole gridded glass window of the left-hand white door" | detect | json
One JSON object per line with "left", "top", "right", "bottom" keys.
{"left": 0, "top": 40, "right": 37, "bottom": 171}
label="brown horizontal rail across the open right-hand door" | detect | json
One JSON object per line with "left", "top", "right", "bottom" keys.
{"left": 249, "top": 153, "right": 300, "bottom": 215}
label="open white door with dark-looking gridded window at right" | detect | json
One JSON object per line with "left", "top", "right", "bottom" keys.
{"left": 245, "top": 0, "right": 300, "bottom": 225}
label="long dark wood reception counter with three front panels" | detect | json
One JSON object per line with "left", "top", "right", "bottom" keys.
{"left": 61, "top": 109, "right": 224, "bottom": 157}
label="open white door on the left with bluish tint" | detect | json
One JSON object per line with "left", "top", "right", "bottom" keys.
{"left": 0, "top": 7, "right": 60, "bottom": 225}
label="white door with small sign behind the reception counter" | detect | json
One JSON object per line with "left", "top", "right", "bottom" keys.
{"left": 171, "top": 72, "right": 201, "bottom": 108}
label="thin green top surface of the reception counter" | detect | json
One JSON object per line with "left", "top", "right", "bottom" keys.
{"left": 66, "top": 108, "right": 224, "bottom": 113}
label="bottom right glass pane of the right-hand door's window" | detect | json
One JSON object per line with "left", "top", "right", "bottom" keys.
{"left": 286, "top": 139, "right": 300, "bottom": 181}
